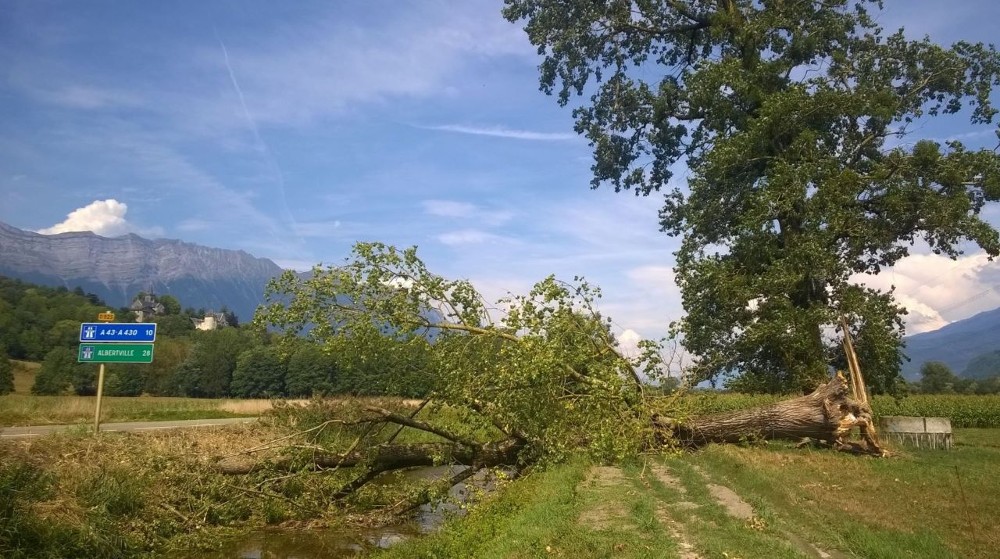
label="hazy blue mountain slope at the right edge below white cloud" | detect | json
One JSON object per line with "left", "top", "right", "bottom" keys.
{"left": 903, "top": 308, "right": 1000, "bottom": 380}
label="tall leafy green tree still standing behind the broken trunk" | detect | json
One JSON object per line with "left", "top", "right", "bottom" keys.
{"left": 504, "top": 0, "right": 1000, "bottom": 391}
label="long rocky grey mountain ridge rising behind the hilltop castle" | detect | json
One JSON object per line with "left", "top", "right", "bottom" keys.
{"left": 0, "top": 223, "right": 283, "bottom": 321}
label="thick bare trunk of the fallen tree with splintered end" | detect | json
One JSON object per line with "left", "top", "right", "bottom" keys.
{"left": 658, "top": 372, "right": 885, "bottom": 456}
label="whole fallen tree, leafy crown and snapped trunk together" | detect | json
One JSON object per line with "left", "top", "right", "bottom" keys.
{"left": 236, "top": 243, "right": 880, "bottom": 516}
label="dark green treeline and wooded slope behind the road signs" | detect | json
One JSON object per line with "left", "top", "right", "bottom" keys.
{"left": 0, "top": 276, "right": 431, "bottom": 398}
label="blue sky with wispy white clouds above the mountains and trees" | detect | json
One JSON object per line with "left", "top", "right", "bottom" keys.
{"left": 0, "top": 0, "right": 1000, "bottom": 350}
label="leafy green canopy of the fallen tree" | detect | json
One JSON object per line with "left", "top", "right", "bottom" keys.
{"left": 254, "top": 243, "right": 655, "bottom": 462}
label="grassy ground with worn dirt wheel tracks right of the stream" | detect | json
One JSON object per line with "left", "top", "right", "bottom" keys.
{"left": 380, "top": 429, "right": 1000, "bottom": 559}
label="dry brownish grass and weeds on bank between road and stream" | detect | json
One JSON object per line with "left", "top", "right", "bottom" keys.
{"left": 0, "top": 423, "right": 342, "bottom": 557}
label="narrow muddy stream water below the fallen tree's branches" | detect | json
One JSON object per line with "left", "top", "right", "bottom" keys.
{"left": 202, "top": 466, "right": 495, "bottom": 559}
